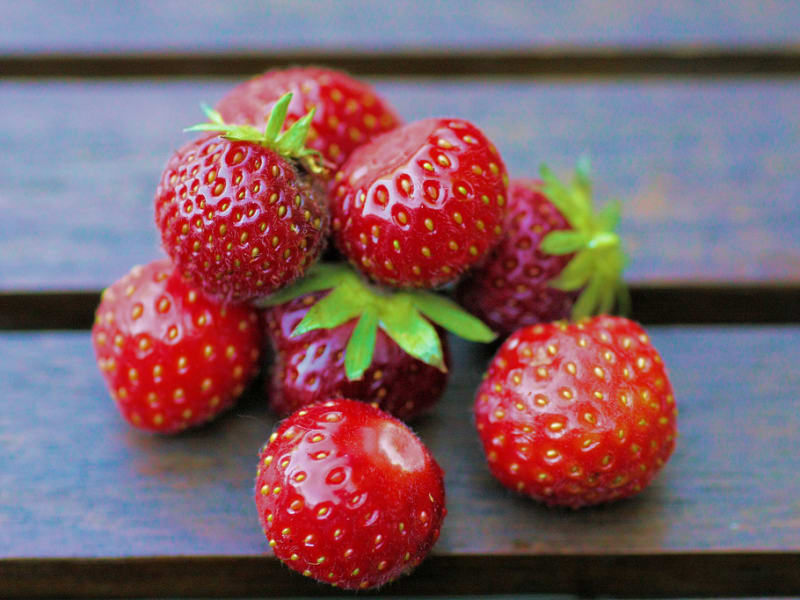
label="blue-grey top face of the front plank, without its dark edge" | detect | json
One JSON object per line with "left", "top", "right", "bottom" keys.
{"left": 0, "top": 327, "right": 800, "bottom": 560}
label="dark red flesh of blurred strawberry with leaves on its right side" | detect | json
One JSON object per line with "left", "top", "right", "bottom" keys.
{"left": 456, "top": 179, "right": 578, "bottom": 335}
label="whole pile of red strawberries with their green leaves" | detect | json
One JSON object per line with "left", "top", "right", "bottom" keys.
{"left": 92, "top": 68, "right": 676, "bottom": 589}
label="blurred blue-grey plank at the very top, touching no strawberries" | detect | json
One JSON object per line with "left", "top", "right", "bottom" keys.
{"left": 0, "top": 0, "right": 800, "bottom": 55}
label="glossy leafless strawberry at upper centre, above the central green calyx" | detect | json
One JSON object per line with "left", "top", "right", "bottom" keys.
{"left": 331, "top": 119, "right": 508, "bottom": 288}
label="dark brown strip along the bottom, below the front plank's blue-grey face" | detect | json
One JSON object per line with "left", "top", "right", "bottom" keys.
{"left": 0, "top": 551, "right": 800, "bottom": 598}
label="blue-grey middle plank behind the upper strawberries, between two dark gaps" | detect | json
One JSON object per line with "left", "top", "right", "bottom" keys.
{"left": 0, "top": 78, "right": 800, "bottom": 290}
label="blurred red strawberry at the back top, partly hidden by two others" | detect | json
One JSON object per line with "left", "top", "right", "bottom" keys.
{"left": 217, "top": 67, "right": 401, "bottom": 168}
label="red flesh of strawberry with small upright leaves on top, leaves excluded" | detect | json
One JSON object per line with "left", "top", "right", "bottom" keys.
{"left": 155, "top": 135, "right": 329, "bottom": 300}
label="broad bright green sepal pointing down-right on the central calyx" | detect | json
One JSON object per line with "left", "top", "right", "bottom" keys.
{"left": 380, "top": 296, "right": 447, "bottom": 372}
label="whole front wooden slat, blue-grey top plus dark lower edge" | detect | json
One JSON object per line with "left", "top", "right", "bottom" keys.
{"left": 0, "top": 327, "right": 800, "bottom": 597}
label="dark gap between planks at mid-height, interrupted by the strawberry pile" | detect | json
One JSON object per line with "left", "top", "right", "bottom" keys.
{"left": 0, "top": 283, "right": 800, "bottom": 331}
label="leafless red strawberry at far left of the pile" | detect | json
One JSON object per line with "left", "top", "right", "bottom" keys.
{"left": 92, "top": 260, "right": 261, "bottom": 433}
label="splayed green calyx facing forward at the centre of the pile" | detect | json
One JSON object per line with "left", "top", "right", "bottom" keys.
{"left": 256, "top": 263, "right": 496, "bottom": 381}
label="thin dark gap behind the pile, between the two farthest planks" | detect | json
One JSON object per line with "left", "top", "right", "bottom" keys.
{"left": 0, "top": 47, "right": 800, "bottom": 78}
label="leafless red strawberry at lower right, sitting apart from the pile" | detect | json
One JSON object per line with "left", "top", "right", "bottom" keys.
{"left": 475, "top": 316, "right": 677, "bottom": 508}
